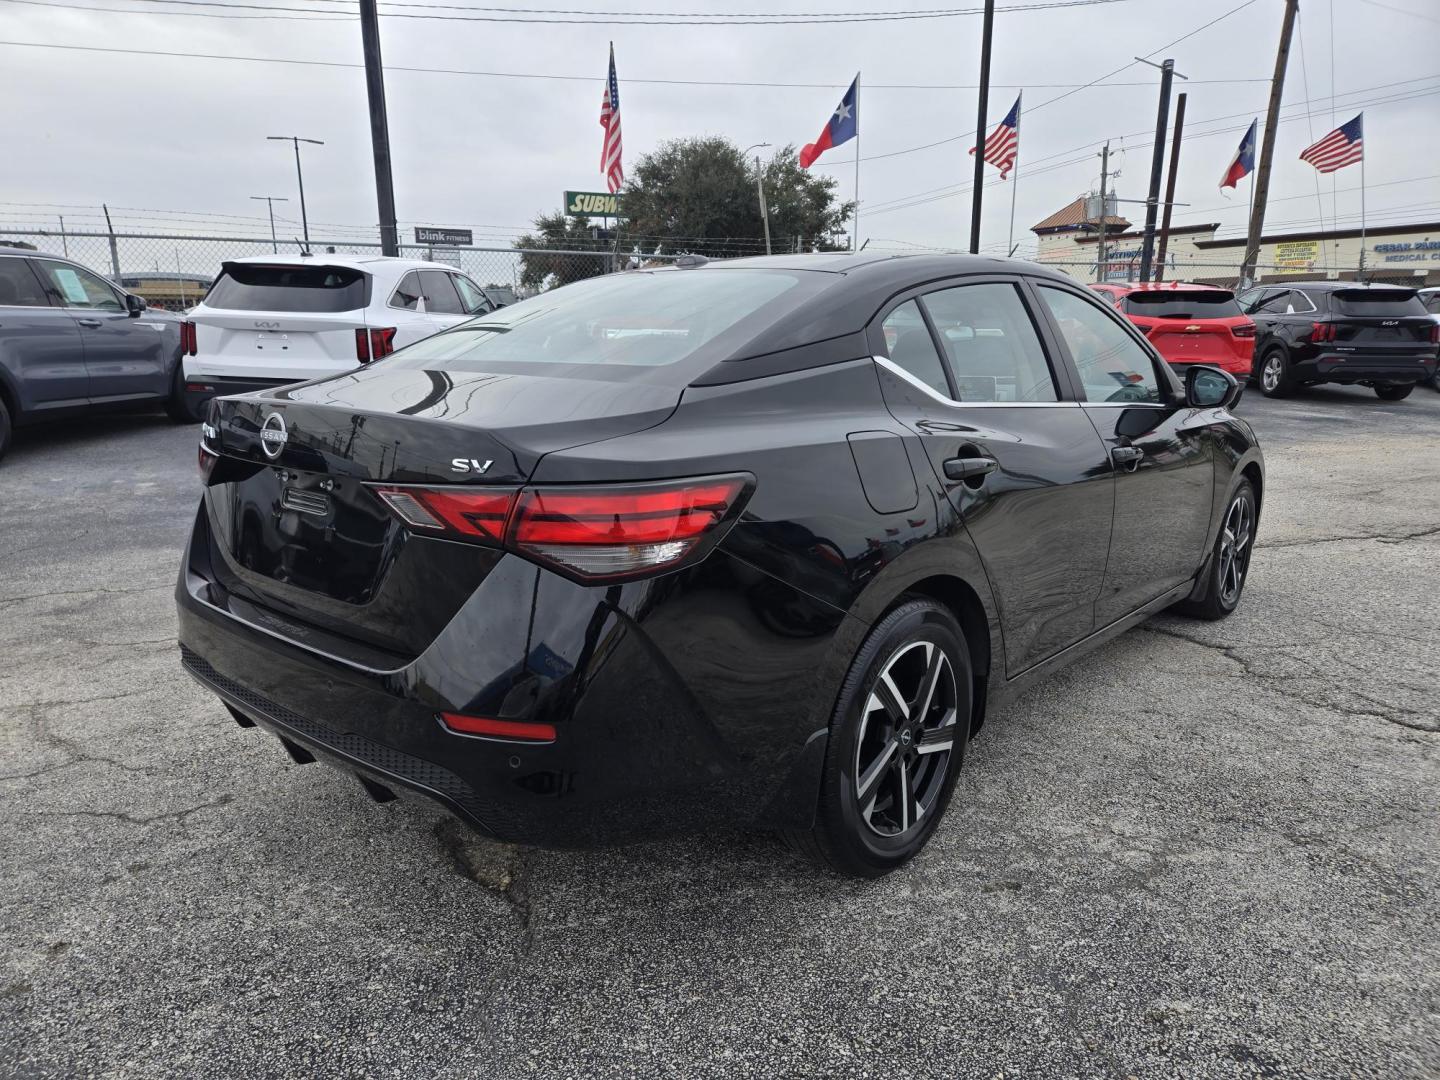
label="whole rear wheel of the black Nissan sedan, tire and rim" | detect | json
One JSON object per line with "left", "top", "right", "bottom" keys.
{"left": 782, "top": 599, "right": 975, "bottom": 877}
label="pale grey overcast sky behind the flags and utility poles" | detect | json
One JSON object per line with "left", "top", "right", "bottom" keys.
{"left": 0, "top": 0, "right": 1440, "bottom": 252}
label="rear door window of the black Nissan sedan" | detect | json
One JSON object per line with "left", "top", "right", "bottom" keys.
{"left": 924, "top": 282, "right": 1058, "bottom": 402}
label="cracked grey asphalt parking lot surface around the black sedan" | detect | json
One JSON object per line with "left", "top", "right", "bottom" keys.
{"left": 0, "top": 387, "right": 1440, "bottom": 1077}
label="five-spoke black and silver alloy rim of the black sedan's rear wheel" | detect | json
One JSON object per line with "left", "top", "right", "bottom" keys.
{"left": 854, "top": 641, "right": 959, "bottom": 838}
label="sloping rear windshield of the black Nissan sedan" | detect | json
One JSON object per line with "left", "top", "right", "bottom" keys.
{"left": 384, "top": 268, "right": 812, "bottom": 383}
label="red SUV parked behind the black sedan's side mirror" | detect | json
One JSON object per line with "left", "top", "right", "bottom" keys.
{"left": 1090, "top": 281, "right": 1256, "bottom": 382}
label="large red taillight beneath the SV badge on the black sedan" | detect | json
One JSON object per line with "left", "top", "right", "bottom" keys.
{"left": 374, "top": 475, "right": 753, "bottom": 582}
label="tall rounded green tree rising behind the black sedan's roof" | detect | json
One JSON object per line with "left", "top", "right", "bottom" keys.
{"left": 621, "top": 137, "right": 855, "bottom": 256}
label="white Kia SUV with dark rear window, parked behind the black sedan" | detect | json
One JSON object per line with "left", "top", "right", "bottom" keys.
{"left": 180, "top": 255, "right": 495, "bottom": 418}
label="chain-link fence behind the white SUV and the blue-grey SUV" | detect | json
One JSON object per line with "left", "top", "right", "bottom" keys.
{"left": 0, "top": 228, "right": 677, "bottom": 311}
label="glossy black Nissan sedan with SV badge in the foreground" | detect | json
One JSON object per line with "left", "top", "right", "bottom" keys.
{"left": 177, "top": 255, "right": 1264, "bottom": 877}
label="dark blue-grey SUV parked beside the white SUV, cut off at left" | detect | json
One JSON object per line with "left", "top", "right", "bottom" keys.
{"left": 0, "top": 248, "right": 184, "bottom": 466}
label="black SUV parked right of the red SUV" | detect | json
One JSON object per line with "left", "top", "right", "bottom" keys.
{"left": 1237, "top": 281, "right": 1440, "bottom": 402}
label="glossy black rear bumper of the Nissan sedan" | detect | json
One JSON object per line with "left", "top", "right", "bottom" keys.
{"left": 176, "top": 506, "right": 848, "bottom": 847}
